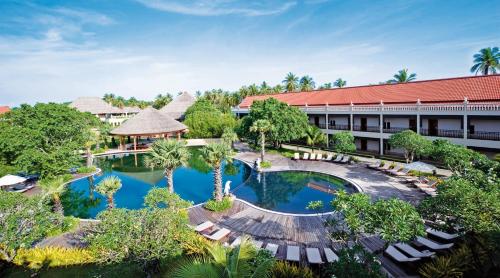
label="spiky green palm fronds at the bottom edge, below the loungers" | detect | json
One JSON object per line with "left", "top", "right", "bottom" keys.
{"left": 172, "top": 237, "right": 274, "bottom": 278}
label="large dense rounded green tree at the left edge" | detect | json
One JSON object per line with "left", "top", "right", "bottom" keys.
{"left": 0, "top": 103, "right": 100, "bottom": 177}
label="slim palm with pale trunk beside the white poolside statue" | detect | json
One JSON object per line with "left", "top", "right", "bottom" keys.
{"left": 201, "top": 143, "right": 234, "bottom": 201}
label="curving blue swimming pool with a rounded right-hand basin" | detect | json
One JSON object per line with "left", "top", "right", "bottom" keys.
{"left": 61, "top": 148, "right": 355, "bottom": 218}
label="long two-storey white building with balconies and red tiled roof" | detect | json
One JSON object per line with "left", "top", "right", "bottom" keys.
{"left": 233, "top": 75, "right": 500, "bottom": 155}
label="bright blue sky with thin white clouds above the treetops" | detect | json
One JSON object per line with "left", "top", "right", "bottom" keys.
{"left": 0, "top": 0, "right": 500, "bottom": 106}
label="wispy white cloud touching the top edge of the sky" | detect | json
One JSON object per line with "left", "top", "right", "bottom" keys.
{"left": 136, "top": 0, "right": 297, "bottom": 16}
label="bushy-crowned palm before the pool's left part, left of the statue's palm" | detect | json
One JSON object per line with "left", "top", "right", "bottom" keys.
{"left": 144, "top": 140, "right": 191, "bottom": 193}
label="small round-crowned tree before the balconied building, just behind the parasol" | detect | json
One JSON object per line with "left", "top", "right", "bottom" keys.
{"left": 389, "top": 130, "right": 431, "bottom": 163}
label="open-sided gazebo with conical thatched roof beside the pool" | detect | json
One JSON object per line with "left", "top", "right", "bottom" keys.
{"left": 110, "top": 107, "right": 187, "bottom": 150}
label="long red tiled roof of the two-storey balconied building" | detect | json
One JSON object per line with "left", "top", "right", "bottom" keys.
{"left": 240, "top": 74, "right": 500, "bottom": 108}
